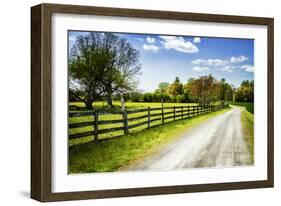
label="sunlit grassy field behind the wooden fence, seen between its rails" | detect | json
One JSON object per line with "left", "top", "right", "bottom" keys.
{"left": 69, "top": 102, "right": 196, "bottom": 146}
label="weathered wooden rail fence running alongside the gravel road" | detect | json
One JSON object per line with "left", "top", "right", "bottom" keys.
{"left": 69, "top": 105, "right": 228, "bottom": 141}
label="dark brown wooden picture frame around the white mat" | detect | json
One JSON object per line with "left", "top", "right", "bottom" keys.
{"left": 31, "top": 4, "right": 274, "bottom": 202}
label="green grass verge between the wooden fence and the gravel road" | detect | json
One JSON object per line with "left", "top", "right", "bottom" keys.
{"left": 69, "top": 109, "right": 229, "bottom": 173}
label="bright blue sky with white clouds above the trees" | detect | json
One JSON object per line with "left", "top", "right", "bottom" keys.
{"left": 69, "top": 32, "right": 254, "bottom": 92}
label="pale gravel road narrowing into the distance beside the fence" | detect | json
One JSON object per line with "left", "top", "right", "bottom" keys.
{"left": 129, "top": 108, "right": 251, "bottom": 170}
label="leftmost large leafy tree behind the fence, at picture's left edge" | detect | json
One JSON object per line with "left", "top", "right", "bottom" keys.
{"left": 69, "top": 34, "right": 108, "bottom": 109}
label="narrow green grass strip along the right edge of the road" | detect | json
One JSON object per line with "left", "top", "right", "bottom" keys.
{"left": 241, "top": 109, "right": 254, "bottom": 163}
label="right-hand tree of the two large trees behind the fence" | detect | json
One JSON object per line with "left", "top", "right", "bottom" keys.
{"left": 99, "top": 33, "right": 141, "bottom": 106}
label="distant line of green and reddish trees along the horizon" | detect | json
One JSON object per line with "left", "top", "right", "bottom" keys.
{"left": 125, "top": 75, "right": 254, "bottom": 105}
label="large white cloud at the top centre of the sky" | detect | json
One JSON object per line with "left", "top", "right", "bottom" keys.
{"left": 159, "top": 36, "right": 199, "bottom": 53}
